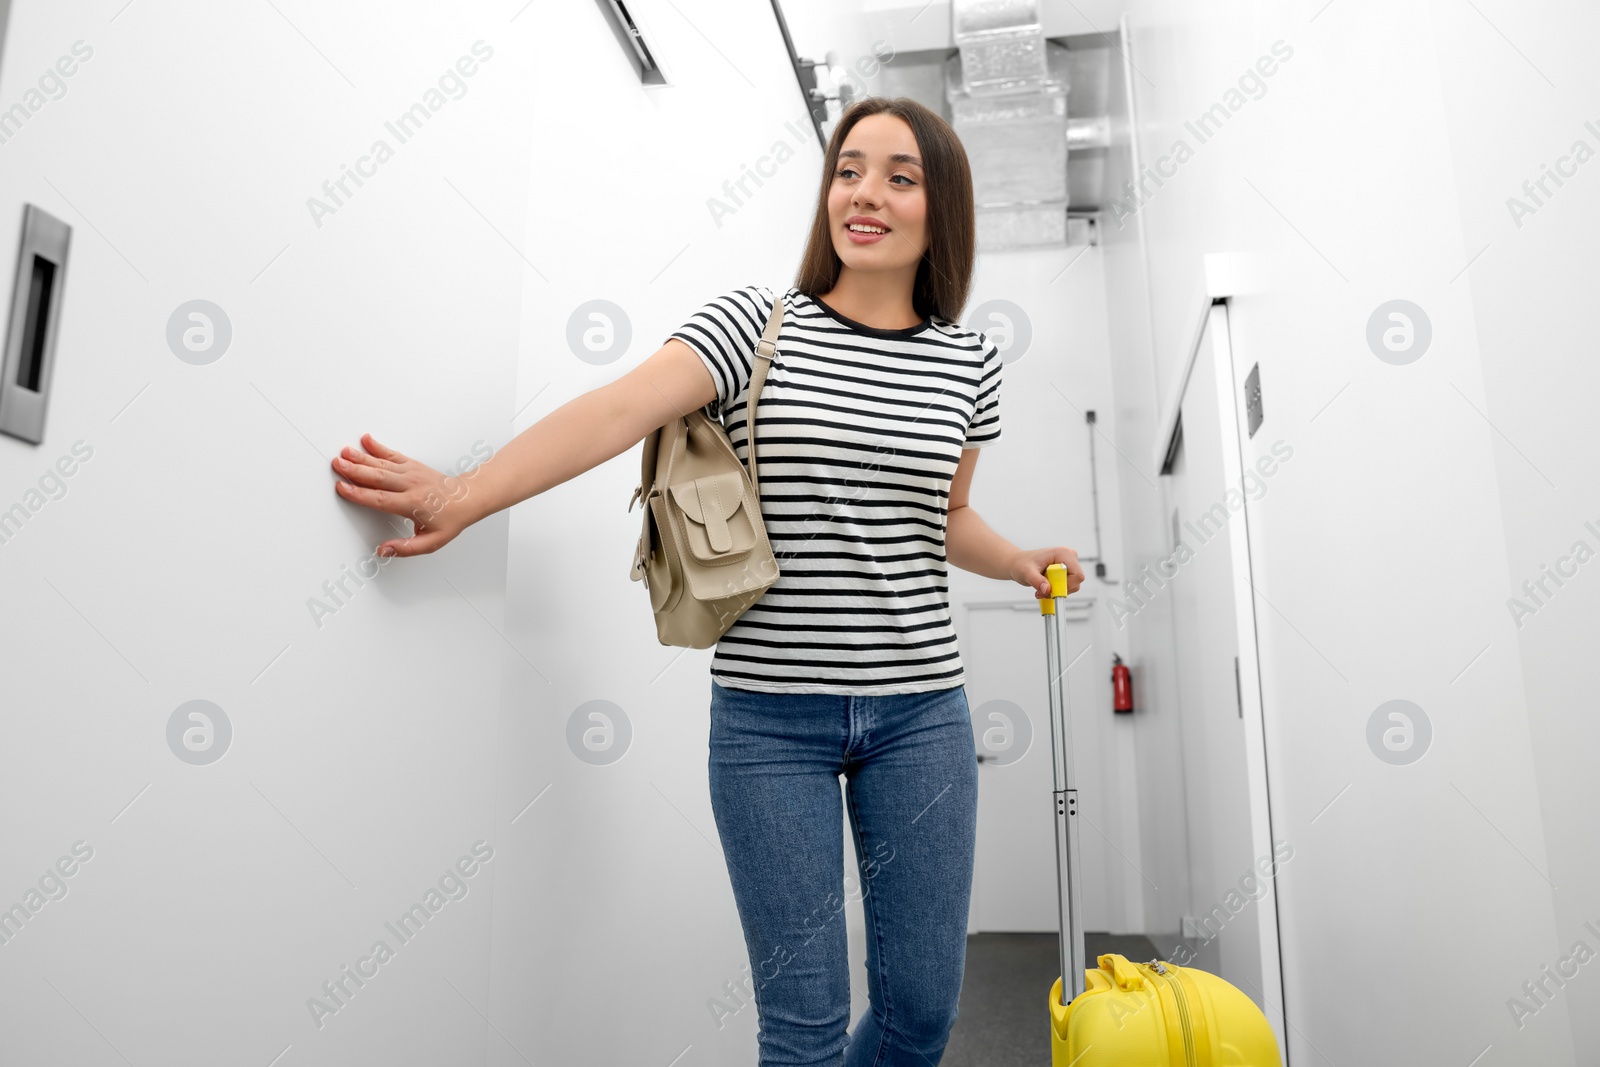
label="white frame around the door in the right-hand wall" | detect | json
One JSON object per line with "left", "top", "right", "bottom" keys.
{"left": 1154, "top": 281, "right": 1290, "bottom": 1065}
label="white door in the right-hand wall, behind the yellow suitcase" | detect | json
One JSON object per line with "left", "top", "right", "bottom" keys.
{"left": 1162, "top": 304, "right": 1283, "bottom": 1048}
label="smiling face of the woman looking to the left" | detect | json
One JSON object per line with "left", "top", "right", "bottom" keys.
{"left": 827, "top": 114, "right": 928, "bottom": 277}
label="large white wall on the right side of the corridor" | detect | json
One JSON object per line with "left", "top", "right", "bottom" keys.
{"left": 1109, "top": 0, "right": 1597, "bottom": 1064}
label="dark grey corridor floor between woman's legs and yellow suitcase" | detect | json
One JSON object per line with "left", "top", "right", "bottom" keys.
{"left": 939, "top": 934, "right": 1158, "bottom": 1067}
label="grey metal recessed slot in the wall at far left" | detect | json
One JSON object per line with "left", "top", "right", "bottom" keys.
{"left": 0, "top": 205, "right": 72, "bottom": 445}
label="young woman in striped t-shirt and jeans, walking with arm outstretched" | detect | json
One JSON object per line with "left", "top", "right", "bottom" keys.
{"left": 334, "top": 98, "right": 1083, "bottom": 1067}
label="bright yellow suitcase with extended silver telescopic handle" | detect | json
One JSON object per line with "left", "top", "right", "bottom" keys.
{"left": 1038, "top": 563, "right": 1283, "bottom": 1067}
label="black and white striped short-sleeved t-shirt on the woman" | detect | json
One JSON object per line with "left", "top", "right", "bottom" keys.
{"left": 672, "top": 285, "right": 1002, "bottom": 694}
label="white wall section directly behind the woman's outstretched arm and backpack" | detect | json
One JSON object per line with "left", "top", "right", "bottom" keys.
{"left": 483, "top": 3, "right": 843, "bottom": 1065}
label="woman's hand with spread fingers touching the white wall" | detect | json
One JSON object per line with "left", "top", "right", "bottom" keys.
{"left": 333, "top": 434, "right": 475, "bottom": 557}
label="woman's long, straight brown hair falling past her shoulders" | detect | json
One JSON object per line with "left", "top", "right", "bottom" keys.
{"left": 795, "top": 96, "right": 978, "bottom": 323}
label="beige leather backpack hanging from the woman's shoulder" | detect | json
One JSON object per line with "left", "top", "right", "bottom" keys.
{"left": 627, "top": 293, "right": 784, "bottom": 648}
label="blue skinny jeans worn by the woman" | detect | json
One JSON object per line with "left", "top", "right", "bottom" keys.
{"left": 709, "top": 681, "right": 978, "bottom": 1067}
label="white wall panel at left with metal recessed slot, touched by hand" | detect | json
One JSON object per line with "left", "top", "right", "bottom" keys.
{"left": 0, "top": 0, "right": 541, "bottom": 1064}
